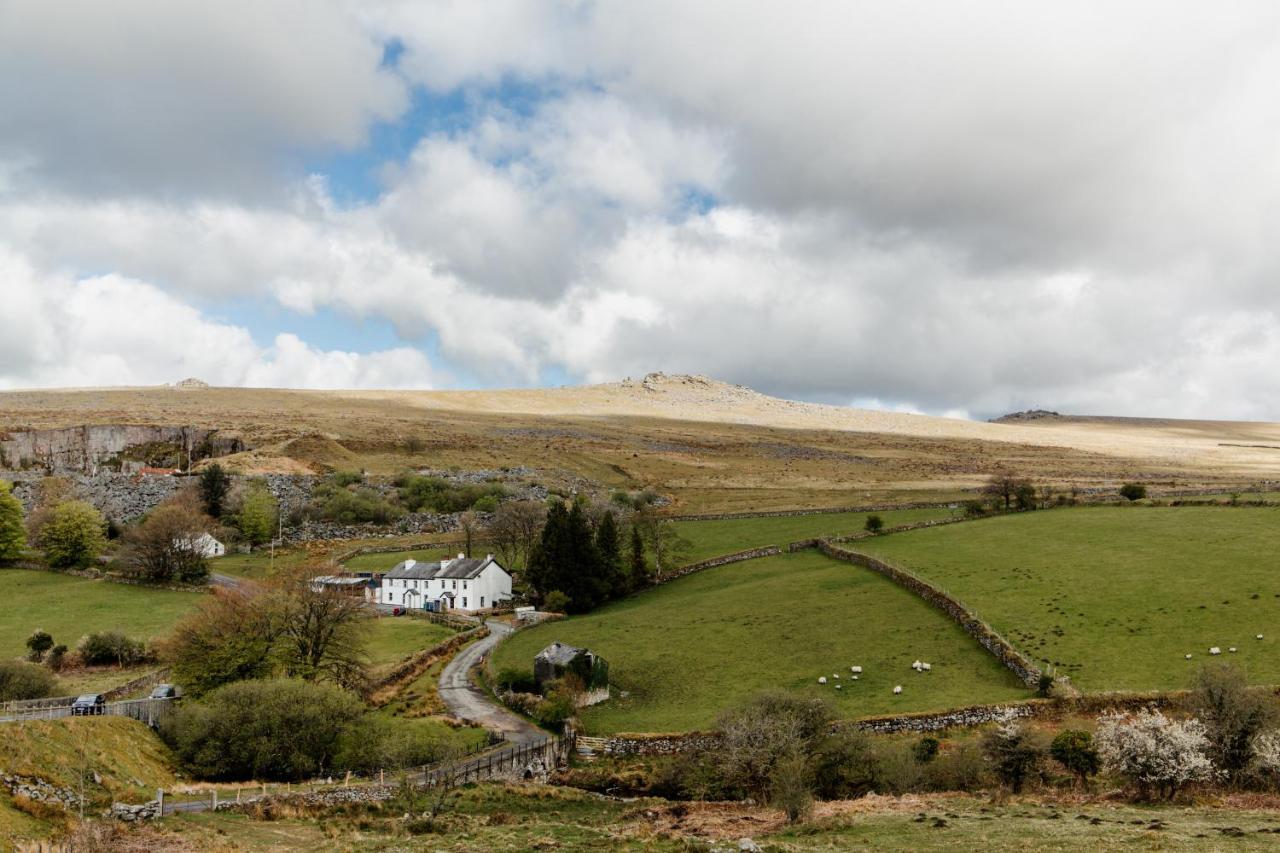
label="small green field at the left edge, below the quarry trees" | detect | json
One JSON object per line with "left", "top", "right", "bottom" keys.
{"left": 0, "top": 569, "right": 204, "bottom": 657}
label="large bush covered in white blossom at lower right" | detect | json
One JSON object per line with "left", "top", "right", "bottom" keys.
{"left": 1094, "top": 708, "right": 1217, "bottom": 798}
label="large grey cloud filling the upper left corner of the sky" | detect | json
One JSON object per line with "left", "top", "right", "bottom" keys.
{"left": 0, "top": 0, "right": 407, "bottom": 197}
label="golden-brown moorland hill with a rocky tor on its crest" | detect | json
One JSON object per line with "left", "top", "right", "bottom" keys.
{"left": 0, "top": 374, "right": 1280, "bottom": 511}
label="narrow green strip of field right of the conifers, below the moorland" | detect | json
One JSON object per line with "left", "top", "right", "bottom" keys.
{"left": 675, "top": 507, "right": 960, "bottom": 562}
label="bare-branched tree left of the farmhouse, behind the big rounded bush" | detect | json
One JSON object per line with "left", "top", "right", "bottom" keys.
{"left": 278, "top": 570, "right": 369, "bottom": 689}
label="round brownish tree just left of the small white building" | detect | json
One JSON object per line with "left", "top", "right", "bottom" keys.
{"left": 123, "top": 502, "right": 210, "bottom": 583}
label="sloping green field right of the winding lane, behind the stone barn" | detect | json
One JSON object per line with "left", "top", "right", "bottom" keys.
{"left": 492, "top": 551, "right": 1028, "bottom": 733}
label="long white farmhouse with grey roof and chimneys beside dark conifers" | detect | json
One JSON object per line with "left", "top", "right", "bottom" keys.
{"left": 378, "top": 553, "right": 511, "bottom": 612}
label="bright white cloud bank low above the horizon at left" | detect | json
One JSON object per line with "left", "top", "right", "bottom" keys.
{"left": 0, "top": 247, "right": 442, "bottom": 388}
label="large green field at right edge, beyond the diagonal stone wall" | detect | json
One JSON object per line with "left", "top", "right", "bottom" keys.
{"left": 856, "top": 506, "right": 1280, "bottom": 690}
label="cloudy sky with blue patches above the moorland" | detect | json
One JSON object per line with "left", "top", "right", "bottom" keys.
{"left": 0, "top": 0, "right": 1280, "bottom": 420}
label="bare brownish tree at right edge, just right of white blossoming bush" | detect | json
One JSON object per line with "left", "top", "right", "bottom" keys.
{"left": 1192, "top": 663, "right": 1276, "bottom": 780}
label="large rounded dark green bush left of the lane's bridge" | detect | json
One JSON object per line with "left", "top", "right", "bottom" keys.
{"left": 160, "top": 679, "right": 365, "bottom": 781}
